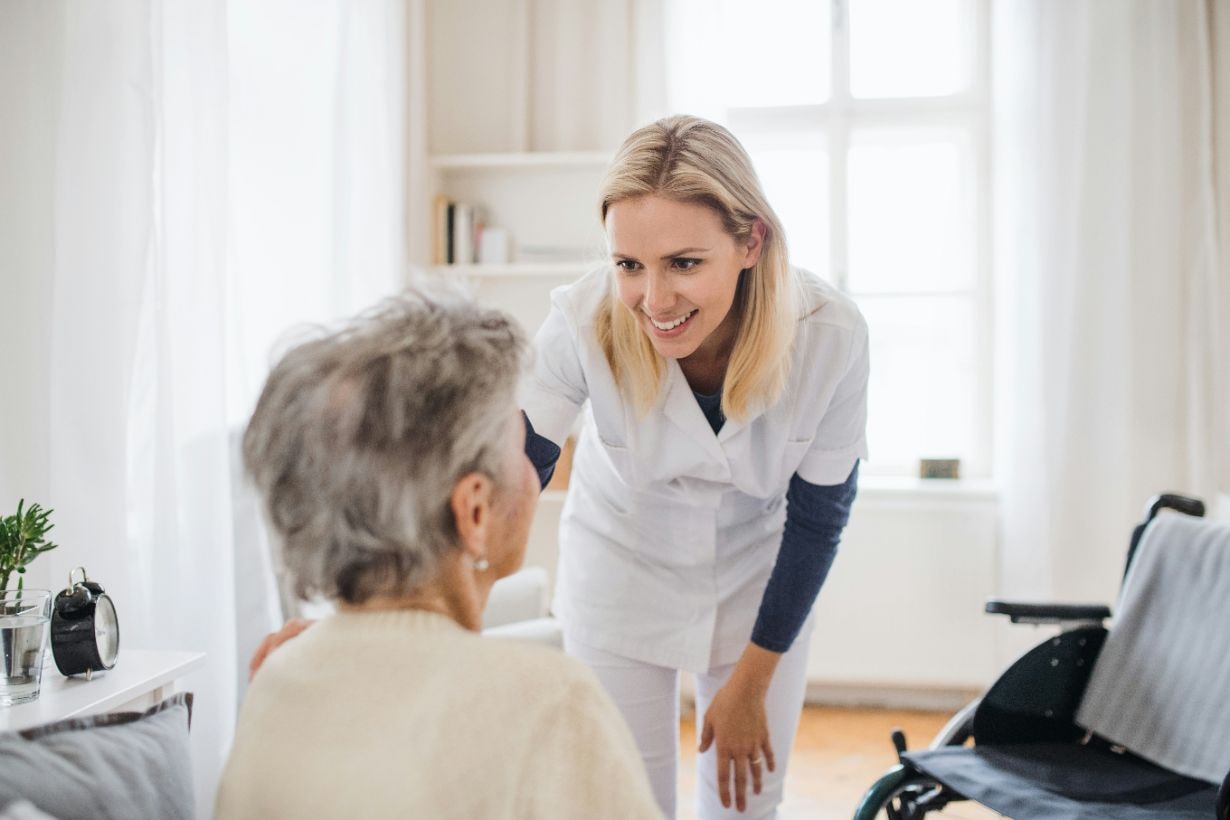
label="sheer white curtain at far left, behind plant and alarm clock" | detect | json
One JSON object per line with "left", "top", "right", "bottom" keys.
{"left": 0, "top": 0, "right": 235, "bottom": 808}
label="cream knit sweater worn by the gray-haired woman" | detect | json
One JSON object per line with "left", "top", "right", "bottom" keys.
{"left": 215, "top": 611, "right": 662, "bottom": 820}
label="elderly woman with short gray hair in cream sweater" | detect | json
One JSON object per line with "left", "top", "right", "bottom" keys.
{"left": 216, "top": 293, "right": 661, "bottom": 820}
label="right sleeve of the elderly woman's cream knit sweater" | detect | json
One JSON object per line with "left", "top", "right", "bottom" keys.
{"left": 517, "top": 680, "right": 662, "bottom": 820}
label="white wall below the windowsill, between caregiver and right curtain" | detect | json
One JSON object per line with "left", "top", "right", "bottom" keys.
{"left": 808, "top": 478, "right": 999, "bottom": 692}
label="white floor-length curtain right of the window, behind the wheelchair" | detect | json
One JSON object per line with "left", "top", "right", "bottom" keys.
{"left": 991, "top": 0, "right": 1230, "bottom": 614}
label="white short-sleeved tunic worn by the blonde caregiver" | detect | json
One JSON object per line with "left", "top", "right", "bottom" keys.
{"left": 522, "top": 268, "right": 868, "bottom": 671}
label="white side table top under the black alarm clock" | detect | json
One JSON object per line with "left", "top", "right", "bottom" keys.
{"left": 0, "top": 649, "right": 205, "bottom": 731}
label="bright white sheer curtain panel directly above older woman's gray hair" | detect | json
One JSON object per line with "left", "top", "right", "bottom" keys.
{"left": 226, "top": 0, "right": 408, "bottom": 423}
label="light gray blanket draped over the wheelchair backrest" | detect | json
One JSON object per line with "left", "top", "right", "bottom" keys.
{"left": 1076, "top": 515, "right": 1230, "bottom": 783}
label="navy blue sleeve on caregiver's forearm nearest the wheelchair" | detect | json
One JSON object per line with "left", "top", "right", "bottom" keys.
{"left": 752, "top": 461, "right": 859, "bottom": 652}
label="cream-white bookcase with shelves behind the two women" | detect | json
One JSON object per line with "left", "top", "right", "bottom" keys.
{"left": 421, "top": 0, "right": 636, "bottom": 583}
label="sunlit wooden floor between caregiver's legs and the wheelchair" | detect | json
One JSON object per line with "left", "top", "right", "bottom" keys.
{"left": 678, "top": 707, "right": 1000, "bottom": 820}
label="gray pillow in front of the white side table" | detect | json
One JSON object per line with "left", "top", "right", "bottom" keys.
{"left": 0, "top": 692, "right": 194, "bottom": 820}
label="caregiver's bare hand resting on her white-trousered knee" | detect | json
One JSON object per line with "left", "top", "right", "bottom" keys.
{"left": 699, "top": 674, "right": 776, "bottom": 811}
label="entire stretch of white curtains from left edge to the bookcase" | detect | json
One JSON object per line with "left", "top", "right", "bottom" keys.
{"left": 0, "top": 0, "right": 406, "bottom": 816}
